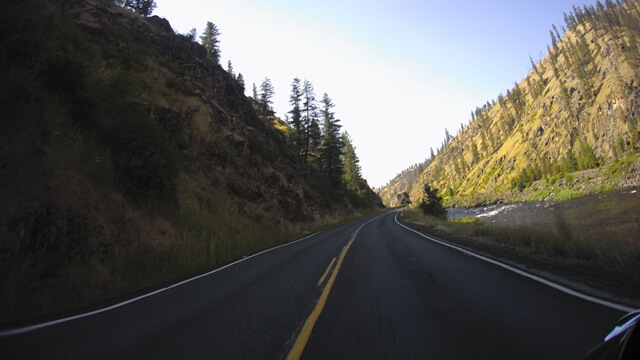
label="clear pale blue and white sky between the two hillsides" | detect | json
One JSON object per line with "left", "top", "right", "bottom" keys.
{"left": 154, "top": 0, "right": 595, "bottom": 187}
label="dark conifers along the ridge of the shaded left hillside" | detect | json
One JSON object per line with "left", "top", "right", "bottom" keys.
{"left": 115, "top": 0, "right": 375, "bottom": 206}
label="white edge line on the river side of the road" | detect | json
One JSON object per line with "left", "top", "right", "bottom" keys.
{"left": 394, "top": 212, "right": 636, "bottom": 312}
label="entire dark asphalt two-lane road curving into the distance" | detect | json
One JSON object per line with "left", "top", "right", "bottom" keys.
{"left": 0, "top": 212, "right": 623, "bottom": 359}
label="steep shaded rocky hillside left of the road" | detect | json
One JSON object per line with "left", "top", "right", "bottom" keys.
{"left": 0, "top": 0, "right": 376, "bottom": 322}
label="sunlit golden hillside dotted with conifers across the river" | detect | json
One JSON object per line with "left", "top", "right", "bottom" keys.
{"left": 380, "top": 1, "right": 640, "bottom": 206}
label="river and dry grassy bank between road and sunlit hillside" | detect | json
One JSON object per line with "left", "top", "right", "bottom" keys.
{"left": 401, "top": 189, "right": 640, "bottom": 305}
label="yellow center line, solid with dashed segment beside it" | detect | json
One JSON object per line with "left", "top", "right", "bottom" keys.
{"left": 287, "top": 218, "right": 375, "bottom": 360}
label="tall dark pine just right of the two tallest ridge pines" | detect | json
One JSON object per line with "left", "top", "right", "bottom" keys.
{"left": 320, "top": 93, "right": 344, "bottom": 189}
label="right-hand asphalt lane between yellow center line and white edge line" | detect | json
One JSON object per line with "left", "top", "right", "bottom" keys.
{"left": 303, "top": 213, "right": 623, "bottom": 359}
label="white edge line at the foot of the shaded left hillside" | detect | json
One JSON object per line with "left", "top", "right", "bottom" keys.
{"left": 0, "top": 232, "right": 320, "bottom": 337}
